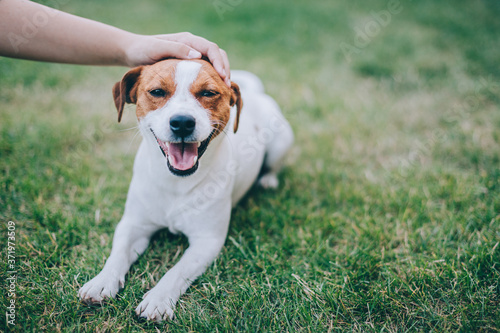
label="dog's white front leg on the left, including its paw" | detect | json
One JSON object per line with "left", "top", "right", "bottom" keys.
{"left": 78, "top": 215, "right": 158, "bottom": 304}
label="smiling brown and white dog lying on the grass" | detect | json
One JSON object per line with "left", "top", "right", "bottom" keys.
{"left": 79, "top": 59, "right": 293, "bottom": 322}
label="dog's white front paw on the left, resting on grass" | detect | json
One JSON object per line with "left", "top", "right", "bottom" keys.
{"left": 78, "top": 272, "right": 125, "bottom": 305}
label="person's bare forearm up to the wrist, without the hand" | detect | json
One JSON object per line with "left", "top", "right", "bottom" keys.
{"left": 0, "top": 0, "right": 137, "bottom": 65}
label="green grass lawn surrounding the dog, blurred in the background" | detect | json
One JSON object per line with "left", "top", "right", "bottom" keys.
{"left": 0, "top": 0, "right": 500, "bottom": 332}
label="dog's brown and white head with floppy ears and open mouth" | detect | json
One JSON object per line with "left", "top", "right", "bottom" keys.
{"left": 113, "top": 59, "right": 242, "bottom": 176}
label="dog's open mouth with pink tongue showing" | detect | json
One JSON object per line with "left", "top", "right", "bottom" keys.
{"left": 151, "top": 129, "right": 213, "bottom": 177}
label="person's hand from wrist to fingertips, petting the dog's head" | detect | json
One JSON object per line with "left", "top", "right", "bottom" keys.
{"left": 124, "top": 32, "right": 231, "bottom": 86}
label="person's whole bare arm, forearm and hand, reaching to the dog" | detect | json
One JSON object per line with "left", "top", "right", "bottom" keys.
{"left": 0, "top": 0, "right": 231, "bottom": 82}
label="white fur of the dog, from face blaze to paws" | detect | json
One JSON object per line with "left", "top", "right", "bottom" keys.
{"left": 79, "top": 61, "right": 293, "bottom": 321}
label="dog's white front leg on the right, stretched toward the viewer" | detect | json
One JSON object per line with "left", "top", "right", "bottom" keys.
{"left": 136, "top": 232, "right": 226, "bottom": 322}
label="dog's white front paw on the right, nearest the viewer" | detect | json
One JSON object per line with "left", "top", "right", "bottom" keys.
{"left": 135, "top": 290, "right": 176, "bottom": 323}
